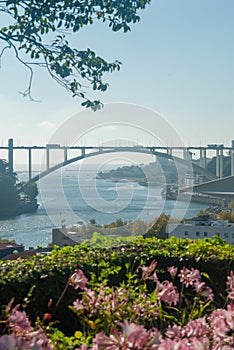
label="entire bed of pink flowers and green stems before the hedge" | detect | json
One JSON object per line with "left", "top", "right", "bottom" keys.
{"left": 0, "top": 261, "right": 234, "bottom": 350}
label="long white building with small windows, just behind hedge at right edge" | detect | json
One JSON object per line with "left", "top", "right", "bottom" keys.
{"left": 167, "top": 216, "right": 234, "bottom": 244}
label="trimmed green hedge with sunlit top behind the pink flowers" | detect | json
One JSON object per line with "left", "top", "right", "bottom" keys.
{"left": 0, "top": 233, "right": 234, "bottom": 334}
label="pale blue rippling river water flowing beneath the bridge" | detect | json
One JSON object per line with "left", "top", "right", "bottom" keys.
{"left": 0, "top": 168, "right": 206, "bottom": 248}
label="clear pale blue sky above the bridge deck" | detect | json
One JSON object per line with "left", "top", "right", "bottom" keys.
{"left": 0, "top": 0, "right": 234, "bottom": 163}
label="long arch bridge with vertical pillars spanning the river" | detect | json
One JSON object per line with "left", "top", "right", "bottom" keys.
{"left": 0, "top": 139, "right": 229, "bottom": 190}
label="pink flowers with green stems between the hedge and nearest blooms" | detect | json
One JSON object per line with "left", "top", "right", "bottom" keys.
{"left": 69, "top": 261, "right": 213, "bottom": 336}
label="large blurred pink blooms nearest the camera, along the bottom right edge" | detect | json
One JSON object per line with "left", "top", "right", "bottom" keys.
{"left": 80, "top": 305, "right": 234, "bottom": 350}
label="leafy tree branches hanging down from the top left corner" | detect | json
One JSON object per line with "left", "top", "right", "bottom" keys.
{"left": 0, "top": 0, "right": 151, "bottom": 108}
